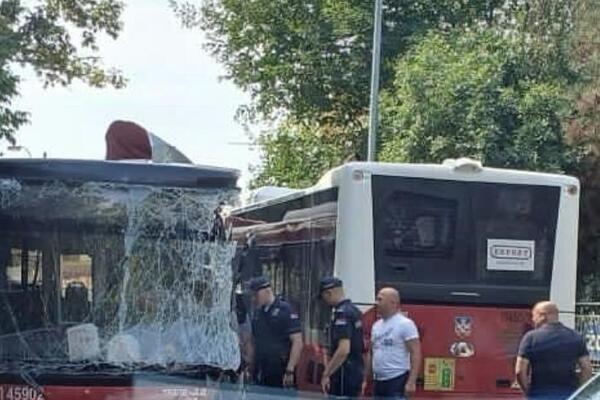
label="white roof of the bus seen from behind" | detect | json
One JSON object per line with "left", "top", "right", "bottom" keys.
{"left": 232, "top": 158, "right": 579, "bottom": 214}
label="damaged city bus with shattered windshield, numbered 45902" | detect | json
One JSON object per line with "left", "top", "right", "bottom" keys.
{"left": 0, "top": 159, "right": 240, "bottom": 400}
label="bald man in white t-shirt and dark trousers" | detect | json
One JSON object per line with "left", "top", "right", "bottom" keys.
{"left": 363, "top": 288, "right": 421, "bottom": 399}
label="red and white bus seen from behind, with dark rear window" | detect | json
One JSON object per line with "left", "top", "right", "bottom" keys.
{"left": 230, "top": 159, "right": 579, "bottom": 398}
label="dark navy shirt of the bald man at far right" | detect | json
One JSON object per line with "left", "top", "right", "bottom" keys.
{"left": 519, "top": 322, "right": 588, "bottom": 395}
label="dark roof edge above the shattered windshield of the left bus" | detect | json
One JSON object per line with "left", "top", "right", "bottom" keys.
{"left": 0, "top": 159, "right": 240, "bottom": 188}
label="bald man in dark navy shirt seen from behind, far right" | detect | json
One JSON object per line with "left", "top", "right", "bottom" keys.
{"left": 515, "top": 301, "right": 592, "bottom": 400}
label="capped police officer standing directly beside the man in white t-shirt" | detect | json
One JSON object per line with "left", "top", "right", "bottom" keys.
{"left": 319, "top": 277, "right": 364, "bottom": 397}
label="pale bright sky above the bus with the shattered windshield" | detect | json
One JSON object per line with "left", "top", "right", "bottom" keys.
{"left": 0, "top": 0, "right": 258, "bottom": 186}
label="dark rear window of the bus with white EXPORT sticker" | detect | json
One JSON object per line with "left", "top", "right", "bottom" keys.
{"left": 373, "top": 176, "right": 560, "bottom": 305}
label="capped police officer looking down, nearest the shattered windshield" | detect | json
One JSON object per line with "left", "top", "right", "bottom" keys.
{"left": 249, "top": 277, "right": 302, "bottom": 387}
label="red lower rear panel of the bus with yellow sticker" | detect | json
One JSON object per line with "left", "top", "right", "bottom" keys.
{"left": 363, "top": 305, "right": 532, "bottom": 398}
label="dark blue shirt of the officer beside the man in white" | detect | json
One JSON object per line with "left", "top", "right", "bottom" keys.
{"left": 329, "top": 299, "right": 364, "bottom": 368}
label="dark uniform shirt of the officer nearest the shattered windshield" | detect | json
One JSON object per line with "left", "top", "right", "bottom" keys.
{"left": 252, "top": 298, "right": 301, "bottom": 362}
